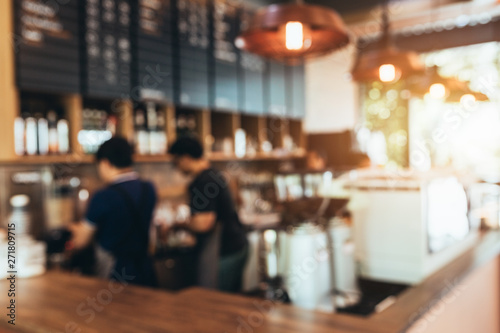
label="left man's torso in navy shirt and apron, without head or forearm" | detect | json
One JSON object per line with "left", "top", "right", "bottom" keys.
{"left": 86, "top": 174, "right": 156, "bottom": 285}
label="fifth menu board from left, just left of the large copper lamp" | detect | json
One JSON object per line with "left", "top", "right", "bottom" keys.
{"left": 212, "top": 0, "right": 240, "bottom": 111}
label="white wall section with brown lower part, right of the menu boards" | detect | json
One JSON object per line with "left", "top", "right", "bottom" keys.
{"left": 304, "top": 44, "right": 360, "bottom": 168}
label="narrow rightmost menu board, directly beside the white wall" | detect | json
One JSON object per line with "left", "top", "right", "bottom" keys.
{"left": 286, "top": 64, "right": 306, "bottom": 119}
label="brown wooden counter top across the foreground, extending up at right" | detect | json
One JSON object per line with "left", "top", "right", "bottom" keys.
{"left": 0, "top": 232, "right": 500, "bottom": 333}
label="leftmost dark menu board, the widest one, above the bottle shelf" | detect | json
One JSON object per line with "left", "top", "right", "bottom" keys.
{"left": 14, "top": 0, "right": 80, "bottom": 93}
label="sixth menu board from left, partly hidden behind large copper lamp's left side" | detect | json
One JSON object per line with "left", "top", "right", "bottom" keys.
{"left": 238, "top": 9, "right": 266, "bottom": 114}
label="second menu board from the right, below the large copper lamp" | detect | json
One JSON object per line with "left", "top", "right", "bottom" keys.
{"left": 267, "top": 61, "right": 287, "bottom": 117}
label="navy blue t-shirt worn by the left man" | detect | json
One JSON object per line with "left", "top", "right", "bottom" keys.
{"left": 86, "top": 179, "right": 157, "bottom": 257}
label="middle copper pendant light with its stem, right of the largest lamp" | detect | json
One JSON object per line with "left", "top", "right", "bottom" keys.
{"left": 351, "top": 2, "right": 423, "bottom": 83}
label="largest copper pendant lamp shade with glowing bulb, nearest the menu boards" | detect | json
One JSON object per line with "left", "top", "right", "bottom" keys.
{"left": 235, "top": 4, "right": 349, "bottom": 63}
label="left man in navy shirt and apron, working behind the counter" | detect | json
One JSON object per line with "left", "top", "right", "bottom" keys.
{"left": 71, "top": 138, "right": 156, "bottom": 286}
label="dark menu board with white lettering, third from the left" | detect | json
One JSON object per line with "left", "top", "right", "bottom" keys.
{"left": 132, "top": 0, "right": 174, "bottom": 101}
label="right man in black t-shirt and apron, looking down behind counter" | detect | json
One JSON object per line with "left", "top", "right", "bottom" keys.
{"left": 170, "top": 137, "right": 248, "bottom": 292}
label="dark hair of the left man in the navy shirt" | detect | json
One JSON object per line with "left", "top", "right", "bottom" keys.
{"left": 96, "top": 137, "right": 134, "bottom": 169}
